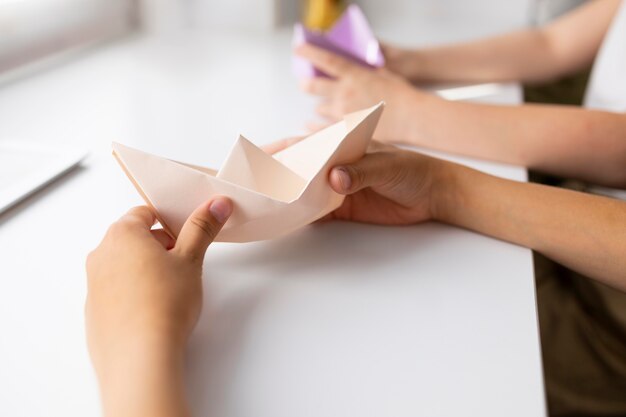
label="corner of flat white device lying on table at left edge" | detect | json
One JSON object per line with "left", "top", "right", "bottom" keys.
{"left": 0, "top": 141, "right": 87, "bottom": 213}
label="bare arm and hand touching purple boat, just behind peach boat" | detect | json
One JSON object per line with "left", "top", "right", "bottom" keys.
{"left": 298, "top": 43, "right": 626, "bottom": 188}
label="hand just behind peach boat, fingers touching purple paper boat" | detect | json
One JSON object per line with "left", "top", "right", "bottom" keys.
{"left": 296, "top": 44, "right": 423, "bottom": 142}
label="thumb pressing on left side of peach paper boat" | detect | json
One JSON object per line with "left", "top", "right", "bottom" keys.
{"left": 174, "top": 196, "right": 233, "bottom": 260}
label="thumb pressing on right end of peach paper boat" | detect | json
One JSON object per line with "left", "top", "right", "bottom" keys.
{"left": 329, "top": 152, "right": 402, "bottom": 195}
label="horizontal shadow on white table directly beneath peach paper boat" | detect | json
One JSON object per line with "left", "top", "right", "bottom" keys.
{"left": 207, "top": 221, "right": 447, "bottom": 279}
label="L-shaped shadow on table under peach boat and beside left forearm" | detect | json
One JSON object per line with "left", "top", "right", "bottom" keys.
{"left": 187, "top": 222, "right": 447, "bottom": 416}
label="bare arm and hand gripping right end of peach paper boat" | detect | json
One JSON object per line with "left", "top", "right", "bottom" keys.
{"left": 320, "top": 145, "right": 626, "bottom": 291}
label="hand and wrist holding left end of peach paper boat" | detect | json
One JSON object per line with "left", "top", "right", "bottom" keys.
{"left": 85, "top": 197, "right": 232, "bottom": 416}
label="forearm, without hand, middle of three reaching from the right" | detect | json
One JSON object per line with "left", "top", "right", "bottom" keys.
{"left": 404, "top": 94, "right": 626, "bottom": 188}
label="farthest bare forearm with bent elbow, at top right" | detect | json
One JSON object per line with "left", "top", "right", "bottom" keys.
{"left": 385, "top": 0, "right": 621, "bottom": 83}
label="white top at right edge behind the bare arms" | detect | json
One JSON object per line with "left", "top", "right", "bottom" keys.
{"left": 584, "top": 0, "right": 626, "bottom": 200}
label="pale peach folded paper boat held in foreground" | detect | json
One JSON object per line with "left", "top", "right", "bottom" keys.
{"left": 113, "top": 103, "right": 384, "bottom": 242}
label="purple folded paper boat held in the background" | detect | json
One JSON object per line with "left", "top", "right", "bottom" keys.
{"left": 293, "top": 4, "right": 385, "bottom": 78}
